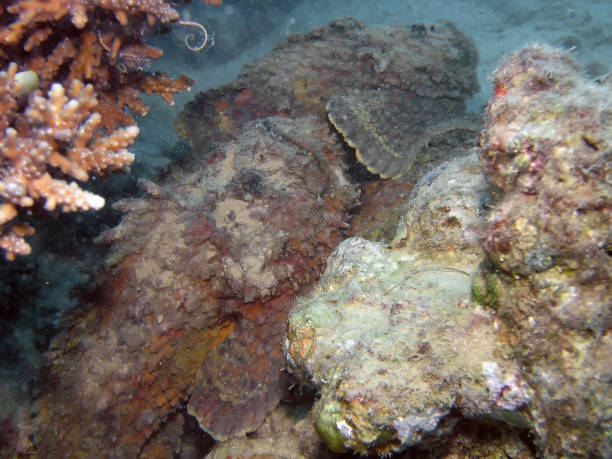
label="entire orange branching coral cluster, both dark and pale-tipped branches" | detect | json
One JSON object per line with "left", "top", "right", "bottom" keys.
{"left": 0, "top": 0, "right": 215, "bottom": 260}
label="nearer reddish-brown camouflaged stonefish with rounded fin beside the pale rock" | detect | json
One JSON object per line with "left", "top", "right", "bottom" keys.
{"left": 27, "top": 118, "right": 356, "bottom": 457}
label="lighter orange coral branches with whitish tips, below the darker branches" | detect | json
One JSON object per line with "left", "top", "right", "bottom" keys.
{"left": 0, "top": 64, "right": 139, "bottom": 260}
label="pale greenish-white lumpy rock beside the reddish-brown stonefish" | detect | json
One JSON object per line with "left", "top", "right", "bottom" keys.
{"left": 286, "top": 154, "right": 530, "bottom": 454}
